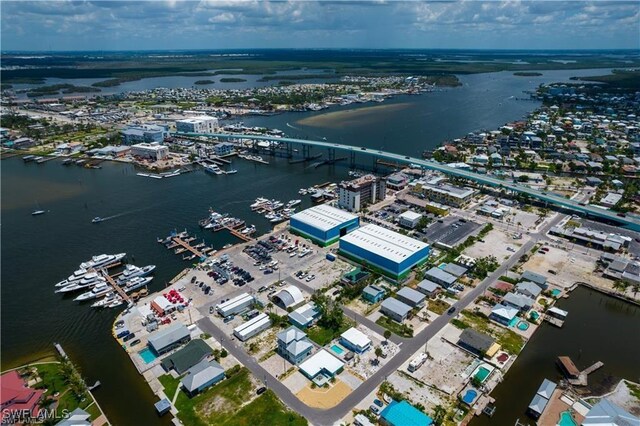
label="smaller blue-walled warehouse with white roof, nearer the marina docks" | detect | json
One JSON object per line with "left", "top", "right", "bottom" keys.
{"left": 289, "top": 204, "right": 360, "bottom": 246}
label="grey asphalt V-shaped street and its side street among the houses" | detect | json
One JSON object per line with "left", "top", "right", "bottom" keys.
{"left": 198, "top": 214, "right": 566, "bottom": 425}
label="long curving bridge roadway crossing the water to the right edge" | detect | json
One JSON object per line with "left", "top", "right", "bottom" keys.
{"left": 175, "top": 133, "right": 640, "bottom": 232}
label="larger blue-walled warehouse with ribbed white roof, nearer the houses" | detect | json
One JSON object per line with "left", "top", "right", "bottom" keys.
{"left": 340, "top": 224, "right": 430, "bottom": 281}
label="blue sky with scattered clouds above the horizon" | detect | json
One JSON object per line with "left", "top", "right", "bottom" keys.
{"left": 0, "top": 0, "right": 640, "bottom": 51}
